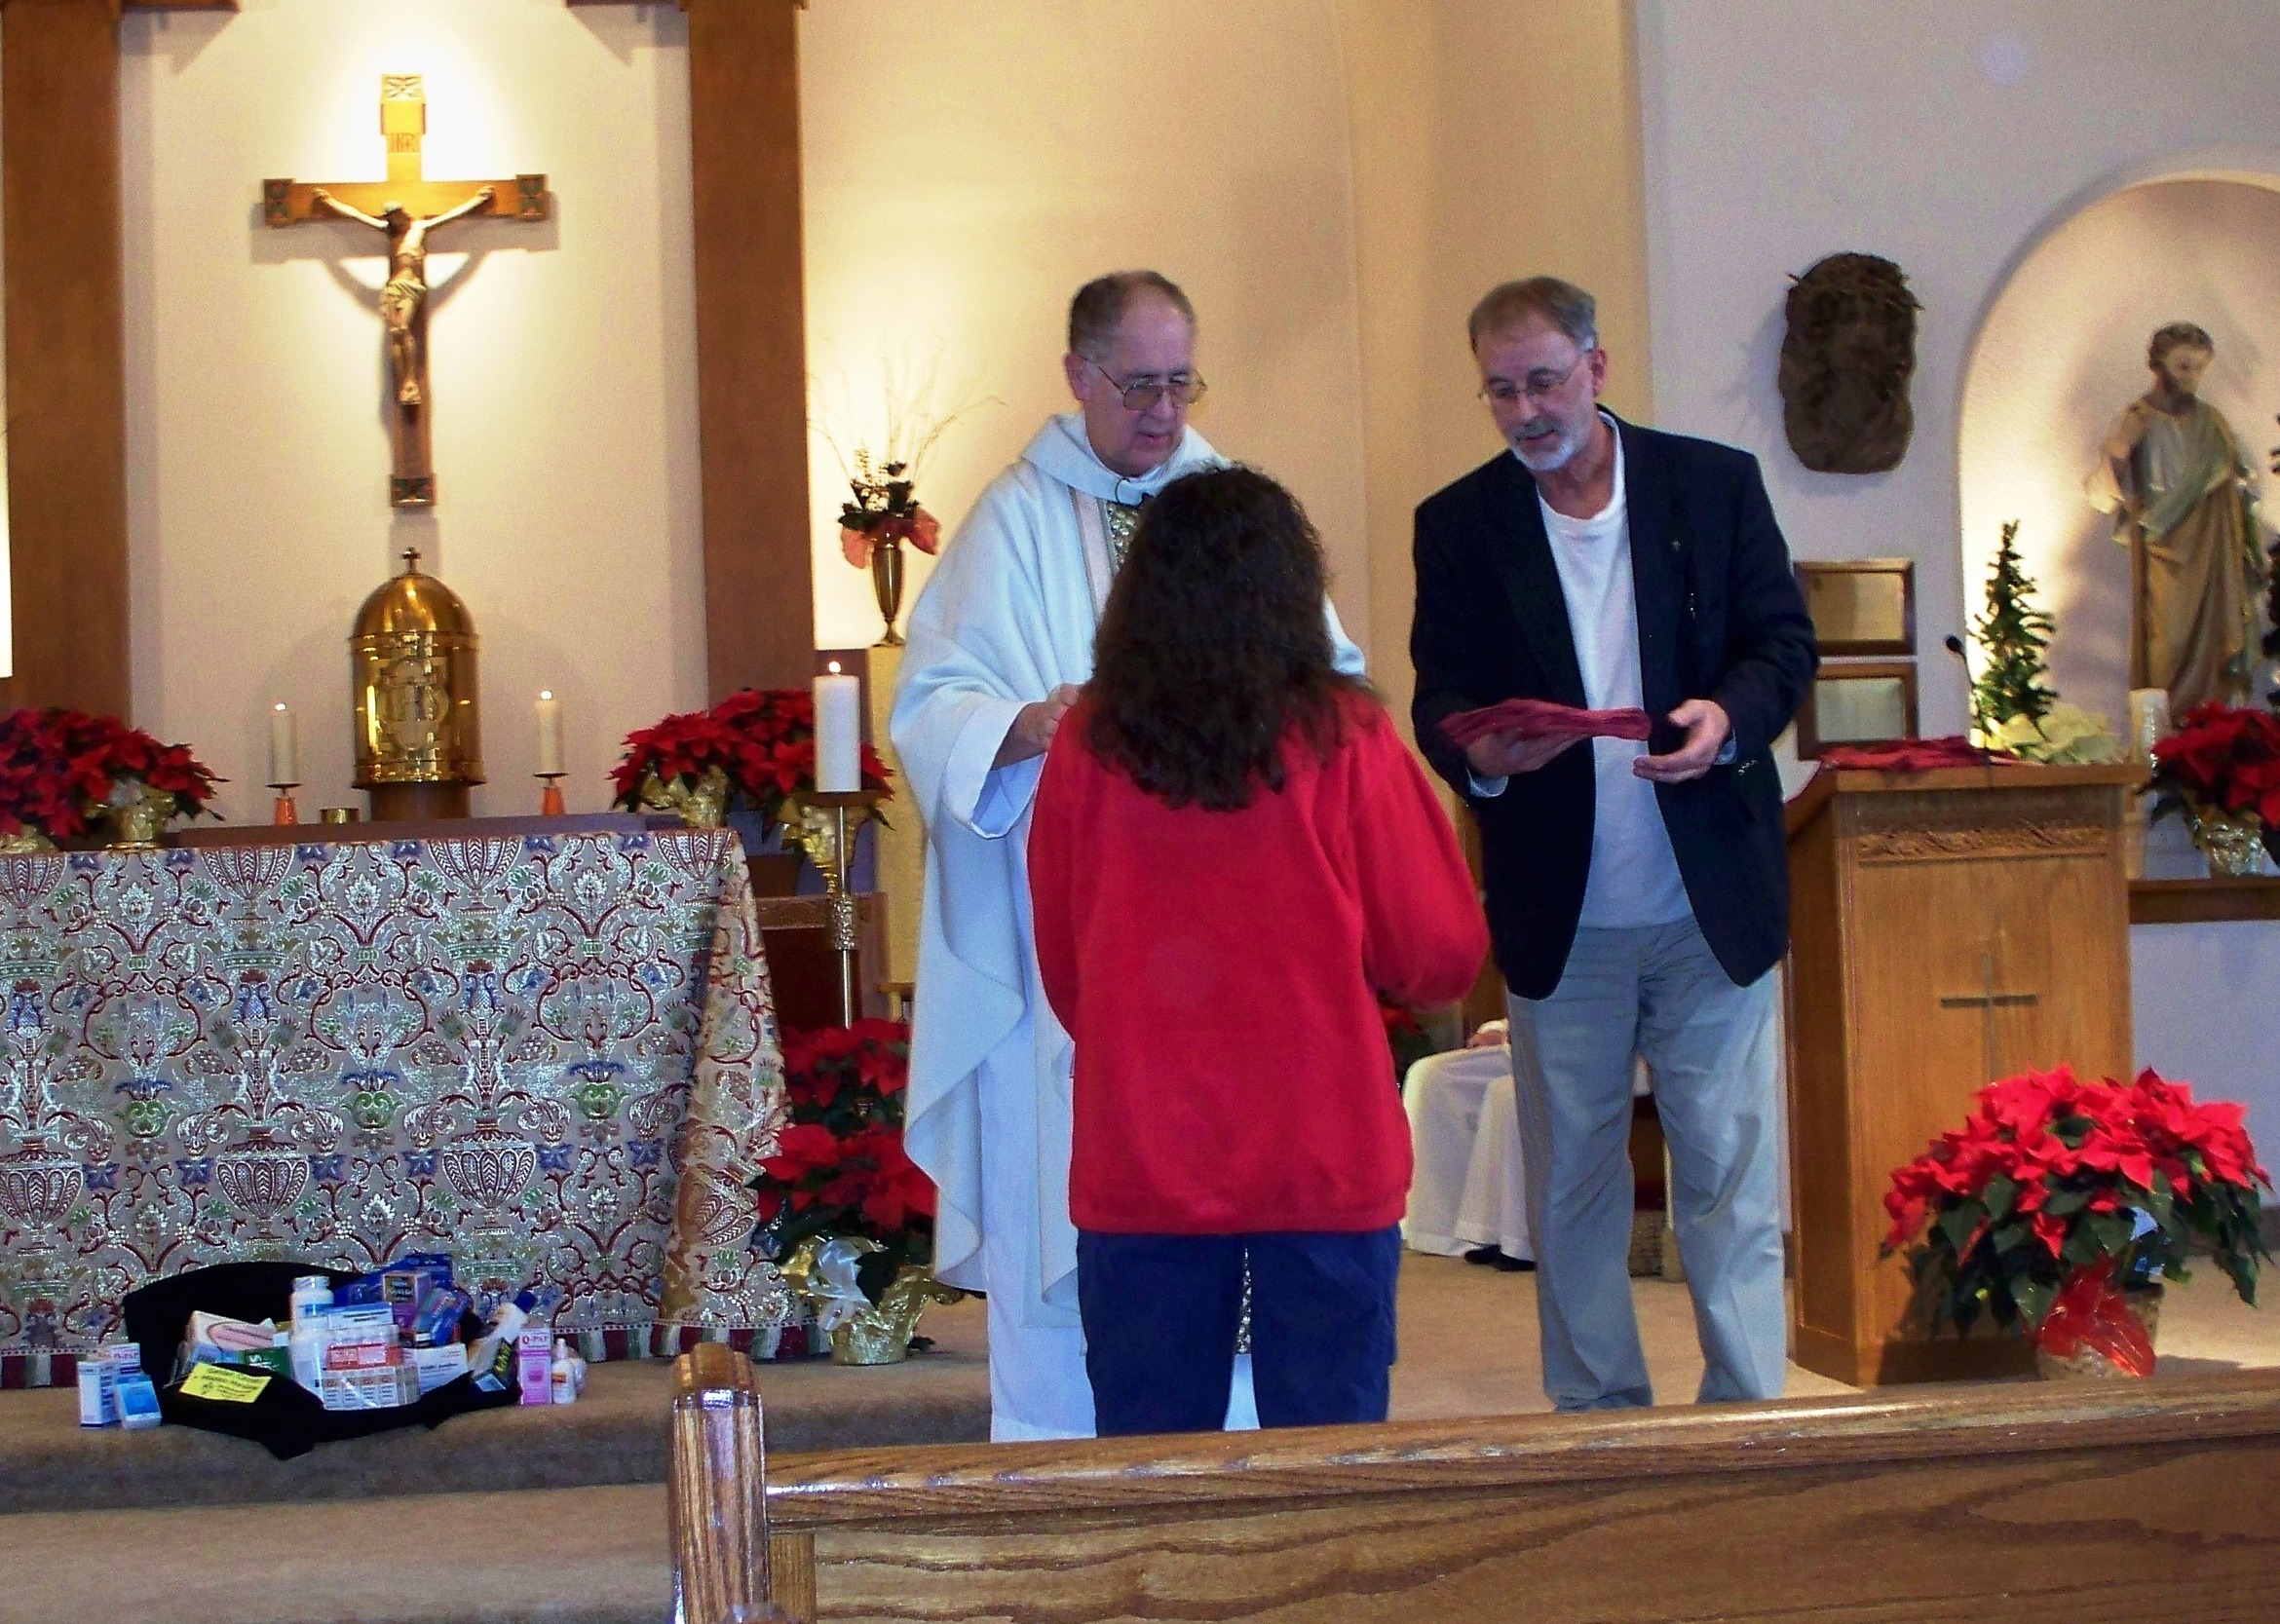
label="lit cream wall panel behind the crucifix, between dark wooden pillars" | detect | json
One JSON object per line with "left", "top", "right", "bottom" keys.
{"left": 121, "top": 0, "right": 704, "bottom": 819}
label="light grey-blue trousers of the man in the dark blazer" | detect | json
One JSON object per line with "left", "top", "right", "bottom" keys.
{"left": 1509, "top": 920, "right": 1788, "bottom": 1410}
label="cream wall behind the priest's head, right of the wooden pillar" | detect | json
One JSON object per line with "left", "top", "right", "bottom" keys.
{"left": 800, "top": 0, "right": 1368, "bottom": 660}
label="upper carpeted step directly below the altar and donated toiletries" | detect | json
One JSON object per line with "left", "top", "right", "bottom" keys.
{"left": 0, "top": 1303, "right": 990, "bottom": 1514}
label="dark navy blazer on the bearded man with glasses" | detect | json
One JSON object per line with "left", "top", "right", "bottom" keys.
{"left": 1409, "top": 422, "right": 1817, "bottom": 999}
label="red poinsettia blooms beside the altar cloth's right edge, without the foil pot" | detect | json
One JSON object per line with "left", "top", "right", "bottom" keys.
{"left": 752, "top": 1020, "right": 934, "bottom": 1303}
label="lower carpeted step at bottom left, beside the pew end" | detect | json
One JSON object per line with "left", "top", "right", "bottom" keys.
{"left": 0, "top": 1483, "right": 672, "bottom": 1624}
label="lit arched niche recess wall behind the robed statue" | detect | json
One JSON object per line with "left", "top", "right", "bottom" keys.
{"left": 1958, "top": 173, "right": 2280, "bottom": 733}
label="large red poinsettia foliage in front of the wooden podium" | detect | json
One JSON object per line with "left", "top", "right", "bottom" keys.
{"left": 1883, "top": 1065, "right": 2271, "bottom": 1369}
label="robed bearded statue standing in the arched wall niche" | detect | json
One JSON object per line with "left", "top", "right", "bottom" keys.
{"left": 2088, "top": 321, "right": 2264, "bottom": 716}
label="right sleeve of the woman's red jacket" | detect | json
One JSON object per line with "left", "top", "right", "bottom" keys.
{"left": 1352, "top": 704, "right": 1489, "bottom": 1008}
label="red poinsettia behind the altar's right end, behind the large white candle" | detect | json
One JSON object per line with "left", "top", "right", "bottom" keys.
{"left": 609, "top": 689, "right": 893, "bottom": 839}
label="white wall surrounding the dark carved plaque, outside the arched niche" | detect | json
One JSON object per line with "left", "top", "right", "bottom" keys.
{"left": 1637, "top": 0, "right": 2280, "bottom": 733}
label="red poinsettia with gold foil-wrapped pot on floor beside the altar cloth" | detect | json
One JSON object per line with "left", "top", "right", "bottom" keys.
{"left": 752, "top": 1020, "right": 962, "bottom": 1364}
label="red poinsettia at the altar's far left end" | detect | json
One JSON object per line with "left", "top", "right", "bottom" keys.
{"left": 0, "top": 707, "right": 216, "bottom": 842}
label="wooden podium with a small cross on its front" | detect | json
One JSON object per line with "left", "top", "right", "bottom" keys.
{"left": 1788, "top": 767, "right": 2144, "bottom": 1387}
